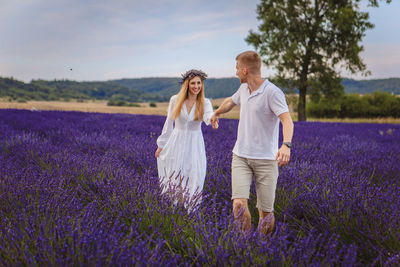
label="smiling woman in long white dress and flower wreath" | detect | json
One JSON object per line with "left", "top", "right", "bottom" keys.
{"left": 155, "top": 70, "right": 214, "bottom": 207}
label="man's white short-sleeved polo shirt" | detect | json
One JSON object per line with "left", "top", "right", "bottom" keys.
{"left": 232, "top": 80, "right": 289, "bottom": 160}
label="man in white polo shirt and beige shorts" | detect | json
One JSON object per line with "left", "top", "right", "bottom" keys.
{"left": 211, "top": 51, "right": 294, "bottom": 234}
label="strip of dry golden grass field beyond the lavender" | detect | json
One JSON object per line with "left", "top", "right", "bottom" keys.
{"left": 0, "top": 98, "right": 400, "bottom": 124}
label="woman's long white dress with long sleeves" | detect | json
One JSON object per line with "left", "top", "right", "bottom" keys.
{"left": 157, "top": 95, "right": 213, "bottom": 206}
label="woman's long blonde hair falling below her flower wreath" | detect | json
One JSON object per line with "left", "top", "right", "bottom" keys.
{"left": 172, "top": 76, "right": 204, "bottom": 120}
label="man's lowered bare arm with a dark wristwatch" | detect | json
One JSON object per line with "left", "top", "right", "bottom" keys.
{"left": 276, "top": 112, "right": 294, "bottom": 166}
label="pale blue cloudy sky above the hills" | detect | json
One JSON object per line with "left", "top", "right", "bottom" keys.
{"left": 0, "top": 0, "right": 400, "bottom": 82}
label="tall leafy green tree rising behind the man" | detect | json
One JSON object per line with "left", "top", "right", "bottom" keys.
{"left": 246, "top": 0, "right": 391, "bottom": 121}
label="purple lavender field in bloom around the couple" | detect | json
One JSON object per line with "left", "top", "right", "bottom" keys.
{"left": 0, "top": 110, "right": 400, "bottom": 266}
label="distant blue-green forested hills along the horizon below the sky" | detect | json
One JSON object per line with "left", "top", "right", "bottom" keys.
{"left": 0, "top": 77, "right": 400, "bottom": 102}
